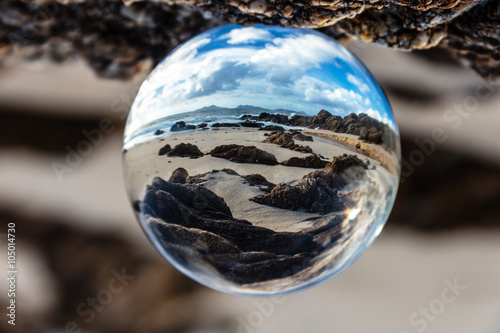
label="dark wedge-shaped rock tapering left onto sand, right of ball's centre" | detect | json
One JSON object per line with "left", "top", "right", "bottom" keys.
{"left": 250, "top": 178, "right": 343, "bottom": 214}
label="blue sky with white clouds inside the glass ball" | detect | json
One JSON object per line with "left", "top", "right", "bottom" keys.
{"left": 129, "top": 25, "right": 394, "bottom": 132}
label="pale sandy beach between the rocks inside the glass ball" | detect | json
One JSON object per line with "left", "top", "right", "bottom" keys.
{"left": 124, "top": 128, "right": 396, "bottom": 232}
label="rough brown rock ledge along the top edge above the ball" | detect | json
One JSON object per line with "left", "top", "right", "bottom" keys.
{"left": 0, "top": 0, "right": 500, "bottom": 82}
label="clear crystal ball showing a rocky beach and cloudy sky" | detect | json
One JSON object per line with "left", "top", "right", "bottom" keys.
{"left": 123, "top": 25, "right": 400, "bottom": 295}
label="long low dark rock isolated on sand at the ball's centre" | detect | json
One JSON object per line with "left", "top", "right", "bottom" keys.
{"left": 209, "top": 144, "right": 278, "bottom": 165}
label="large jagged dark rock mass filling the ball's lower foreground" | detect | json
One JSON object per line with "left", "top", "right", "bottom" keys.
{"left": 136, "top": 169, "right": 342, "bottom": 283}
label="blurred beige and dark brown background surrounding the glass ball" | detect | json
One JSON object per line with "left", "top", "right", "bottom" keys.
{"left": 0, "top": 0, "right": 500, "bottom": 333}
